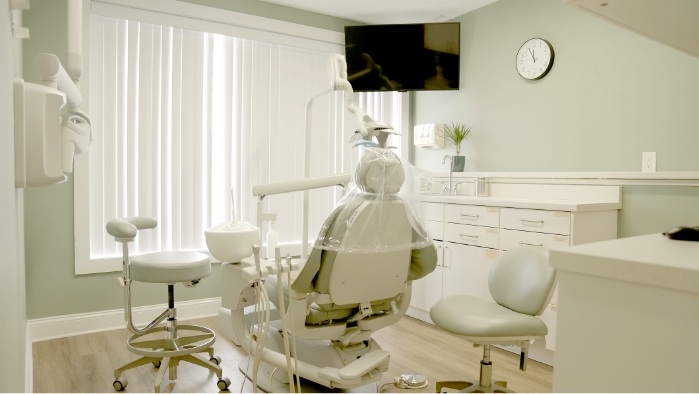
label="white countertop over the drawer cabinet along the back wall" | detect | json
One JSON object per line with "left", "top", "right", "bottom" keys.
{"left": 419, "top": 194, "right": 621, "bottom": 212}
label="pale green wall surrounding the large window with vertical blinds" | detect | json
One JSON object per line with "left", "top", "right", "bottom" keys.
{"left": 24, "top": 0, "right": 352, "bottom": 319}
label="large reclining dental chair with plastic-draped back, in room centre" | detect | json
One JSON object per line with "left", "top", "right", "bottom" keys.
{"left": 212, "top": 148, "right": 437, "bottom": 392}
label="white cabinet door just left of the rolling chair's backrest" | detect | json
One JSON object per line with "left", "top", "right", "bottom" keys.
{"left": 442, "top": 242, "right": 498, "bottom": 300}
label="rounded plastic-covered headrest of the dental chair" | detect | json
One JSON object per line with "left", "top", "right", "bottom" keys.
{"left": 354, "top": 148, "right": 405, "bottom": 194}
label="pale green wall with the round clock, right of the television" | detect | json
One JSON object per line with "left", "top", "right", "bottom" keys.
{"left": 411, "top": 0, "right": 699, "bottom": 237}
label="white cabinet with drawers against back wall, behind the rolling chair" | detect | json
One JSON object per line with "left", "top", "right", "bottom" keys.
{"left": 408, "top": 187, "right": 621, "bottom": 364}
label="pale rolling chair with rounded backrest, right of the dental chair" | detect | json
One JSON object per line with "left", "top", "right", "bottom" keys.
{"left": 430, "top": 246, "right": 556, "bottom": 393}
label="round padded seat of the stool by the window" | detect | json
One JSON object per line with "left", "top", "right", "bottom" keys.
{"left": 130, "top": 251, "right": 211, "bottom": 283}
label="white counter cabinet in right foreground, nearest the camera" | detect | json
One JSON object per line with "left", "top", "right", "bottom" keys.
{"left": 551, "top": 234, "right": 699, "bottom": 393}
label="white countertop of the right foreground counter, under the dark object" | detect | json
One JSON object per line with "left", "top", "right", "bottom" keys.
{"left": 550, "top": 233, "right": 699, "bottom": 293}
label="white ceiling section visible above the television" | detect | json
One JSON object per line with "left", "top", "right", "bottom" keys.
{"left": 264, "top": 0, "right": 497, "bottom": 24}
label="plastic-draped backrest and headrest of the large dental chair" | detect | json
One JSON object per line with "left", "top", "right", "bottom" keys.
{"left": 292, "top": 149, "right": 414, "bottom": 339}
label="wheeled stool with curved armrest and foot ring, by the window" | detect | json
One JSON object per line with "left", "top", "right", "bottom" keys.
{"left": 107, "top": 217, "right": 230, "bottom": 393}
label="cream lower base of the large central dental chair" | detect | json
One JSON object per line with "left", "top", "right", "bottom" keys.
{"left": 220, "top": 259, "right": 394, "bottom": 392}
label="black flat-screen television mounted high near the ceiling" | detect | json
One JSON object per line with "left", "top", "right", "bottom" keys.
{"left": 345, "top": 22, "right": 461, "bottom": 92}
